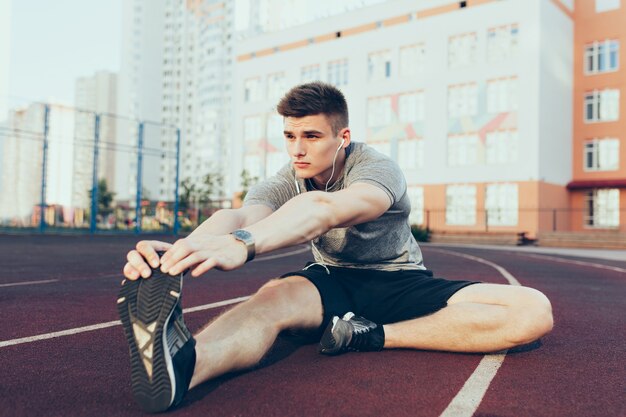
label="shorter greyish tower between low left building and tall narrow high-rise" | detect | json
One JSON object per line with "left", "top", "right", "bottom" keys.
{"left": 72, "top": 71, "right": 120, "bottom": 208}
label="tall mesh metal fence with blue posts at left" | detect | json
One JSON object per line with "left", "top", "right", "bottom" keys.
{"left": 0, "top": 103, "right": 230, "bottom": 234}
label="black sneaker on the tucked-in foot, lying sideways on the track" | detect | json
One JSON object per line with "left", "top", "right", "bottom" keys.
{"left": 320, "top": 313, "right": 385, "bottom": 355}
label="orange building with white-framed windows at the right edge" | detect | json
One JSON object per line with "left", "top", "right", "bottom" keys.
{"left": 568, "top": 0, "right": 626, "bottom": 233}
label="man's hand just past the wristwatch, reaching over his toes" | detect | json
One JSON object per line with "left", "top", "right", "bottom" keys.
{"left": 161, "top": 235, "right": 248, "bottom": 277}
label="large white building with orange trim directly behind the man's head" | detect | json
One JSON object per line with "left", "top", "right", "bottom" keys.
{"left": 233, "top": 0, "right": 574, "bottom": 237}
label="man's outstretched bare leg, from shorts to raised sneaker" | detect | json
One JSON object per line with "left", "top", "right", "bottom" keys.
{"left": 189, "top": 276, "right": 323, "bottom": 389}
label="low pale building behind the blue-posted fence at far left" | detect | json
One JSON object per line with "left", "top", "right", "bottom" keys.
{"left": 0, "top": 103, "right": 76, "bottom": 226}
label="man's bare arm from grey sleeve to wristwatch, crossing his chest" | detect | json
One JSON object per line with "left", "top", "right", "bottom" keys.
{"left": 245, "top": 183, "right": 392, "bottom": 253}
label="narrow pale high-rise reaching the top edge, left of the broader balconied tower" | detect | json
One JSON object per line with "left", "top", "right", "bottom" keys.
{"left": 112, "top": 0, "right": 166, "bottom": 206}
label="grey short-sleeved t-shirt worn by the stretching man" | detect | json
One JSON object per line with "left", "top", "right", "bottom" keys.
{"left": 244, "top": 142, "right": 426, "bottom": 271}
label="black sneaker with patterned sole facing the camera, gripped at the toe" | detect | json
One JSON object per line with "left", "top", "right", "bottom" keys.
{"left": 117, "top": 256, "right": 196, "bottom": 413}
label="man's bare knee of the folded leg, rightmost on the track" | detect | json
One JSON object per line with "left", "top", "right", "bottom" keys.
{"left": 509, "top": 287, "right": 554, "bottom": 345}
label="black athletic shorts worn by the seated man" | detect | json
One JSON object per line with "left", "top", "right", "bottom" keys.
{"left": 281, "top": 262, "right": 478, "bottom": 332}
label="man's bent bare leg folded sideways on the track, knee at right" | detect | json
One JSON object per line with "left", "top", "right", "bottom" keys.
{"left": 384, "top": 284, "right": 553, "bottom": 352}
